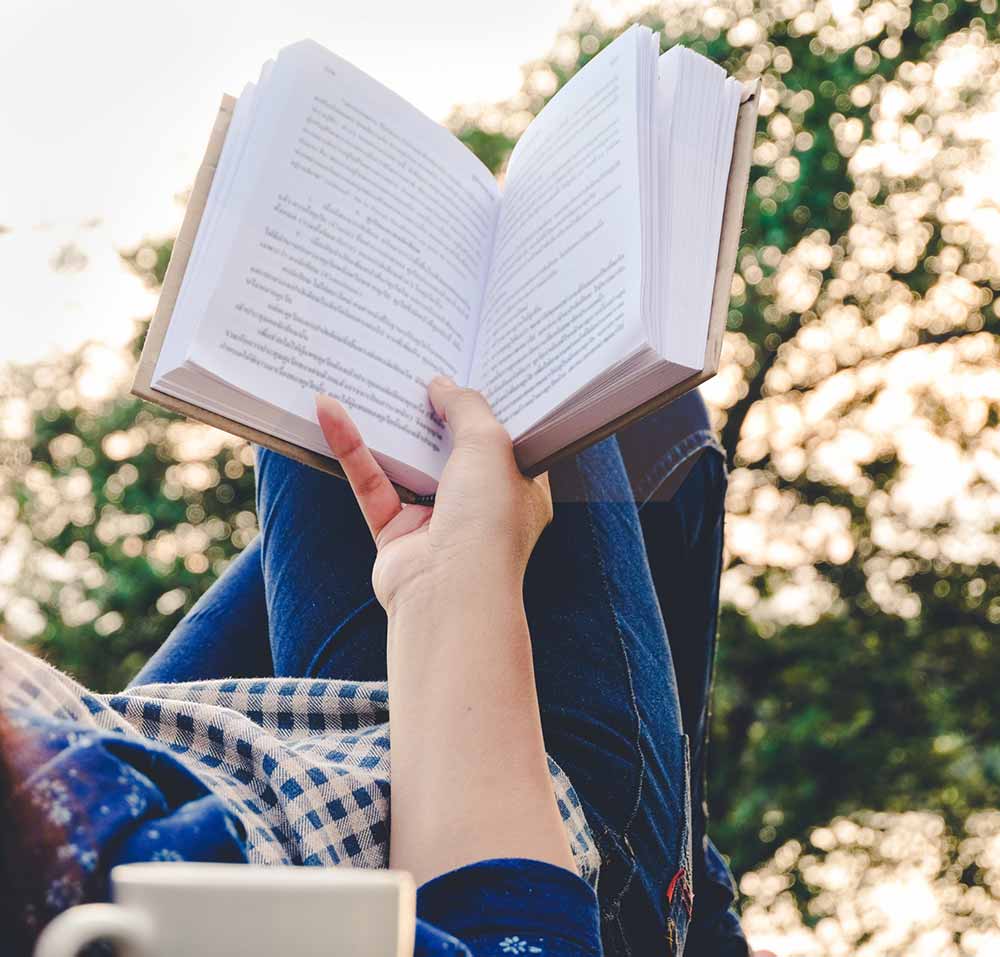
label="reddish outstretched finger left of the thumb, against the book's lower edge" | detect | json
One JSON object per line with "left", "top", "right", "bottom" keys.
{"left": 316, "top": 395, "right": 403, "bottom": 539}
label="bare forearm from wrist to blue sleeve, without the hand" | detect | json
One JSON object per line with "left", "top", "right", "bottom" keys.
{"left": 388, "top": 567, "right": 573, "bottom": 882}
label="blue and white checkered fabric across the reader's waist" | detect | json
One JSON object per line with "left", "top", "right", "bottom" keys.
{"left": 0, "top": 639, "right": 600, "bottom": 885}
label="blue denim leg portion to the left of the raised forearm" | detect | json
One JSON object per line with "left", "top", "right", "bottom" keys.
{"left": 130, "top": 448, "right": 386, "bottom": 687}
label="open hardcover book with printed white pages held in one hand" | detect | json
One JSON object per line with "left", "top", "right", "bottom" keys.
{"left": 133, "top": 26, "right": 757, "bottom": 494}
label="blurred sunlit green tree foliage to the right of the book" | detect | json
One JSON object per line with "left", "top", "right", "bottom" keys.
{"left": 454, "top": 0, "right": 1000, "bottom": 866}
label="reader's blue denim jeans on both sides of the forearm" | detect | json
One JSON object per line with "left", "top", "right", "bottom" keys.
{"left": 135, "top": 393, "right": 747, "bottom": 957}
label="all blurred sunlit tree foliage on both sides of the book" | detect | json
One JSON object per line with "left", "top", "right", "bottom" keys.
{"left": 0, "top": 0, "right": 1000, "bottom": 953}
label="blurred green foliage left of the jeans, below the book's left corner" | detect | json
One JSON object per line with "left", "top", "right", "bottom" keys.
{"left": 0, "top": 310, "right": 257, "bottom": 691}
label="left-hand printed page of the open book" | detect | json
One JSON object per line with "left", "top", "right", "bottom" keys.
{"left": 188, "top": 41, "right": 498, "bottom": 474}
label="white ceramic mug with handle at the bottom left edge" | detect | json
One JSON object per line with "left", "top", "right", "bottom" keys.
{"left": 35, "top": 863, "right": 416, "bottom": 957}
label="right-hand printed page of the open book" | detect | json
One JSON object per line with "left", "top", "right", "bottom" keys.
{"left": 469, "top": 27, "right": 648, "bottom": 438}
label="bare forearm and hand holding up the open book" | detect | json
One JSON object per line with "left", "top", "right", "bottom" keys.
{"left": 318, "top": 379, "right": 574, "bottom": 882}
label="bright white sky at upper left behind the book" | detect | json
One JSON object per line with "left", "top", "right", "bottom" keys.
{"left": 0, "top": 0, "right": 573, "bottom": 361}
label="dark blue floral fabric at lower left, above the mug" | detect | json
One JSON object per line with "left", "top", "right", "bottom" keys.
{"left": 4, "top": 709, "right": 246, "bottom": 932}
